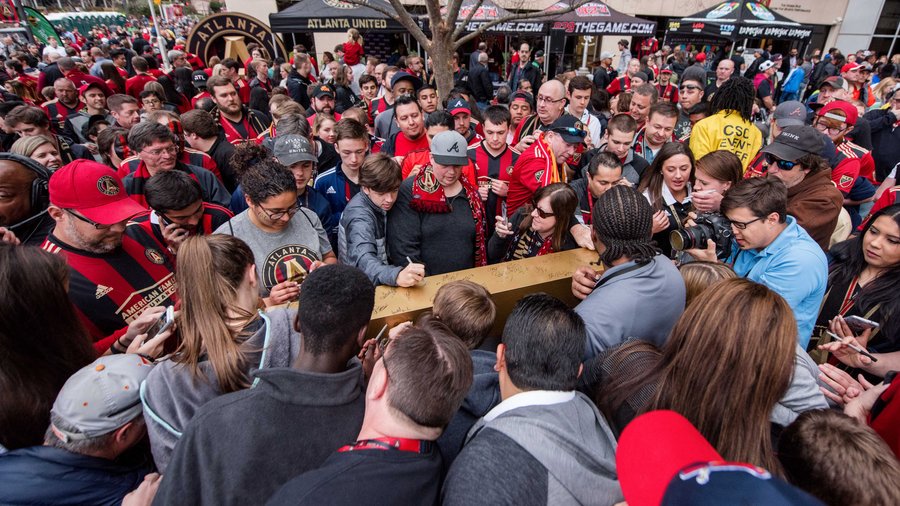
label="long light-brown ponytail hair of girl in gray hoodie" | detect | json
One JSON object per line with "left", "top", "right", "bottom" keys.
{"left": 172, "top": 234, "right": 256, "bottom": 393}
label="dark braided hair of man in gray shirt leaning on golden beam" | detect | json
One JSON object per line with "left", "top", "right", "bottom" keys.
{"left": 591, "top": 186, "right": 659, "bottom": 266}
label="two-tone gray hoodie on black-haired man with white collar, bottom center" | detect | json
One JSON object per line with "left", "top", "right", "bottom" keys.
{"left": 442, "top": 392, "right": 622, "bottom": 505}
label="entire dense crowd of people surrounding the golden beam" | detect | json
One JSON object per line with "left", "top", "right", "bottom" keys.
{"left": 0, "top": 15, "right": 900, "bottom": 506}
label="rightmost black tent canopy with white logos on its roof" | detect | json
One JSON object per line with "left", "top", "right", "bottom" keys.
{"left": 666, "top": 0, "right": 812, "bottom": 41}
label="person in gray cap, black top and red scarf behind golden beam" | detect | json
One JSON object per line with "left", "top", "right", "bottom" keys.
{"left": 387, "top": 131, "right": 487, "bottom": 276}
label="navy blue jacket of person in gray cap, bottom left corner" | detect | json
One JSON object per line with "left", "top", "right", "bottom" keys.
{"left": 0, "top": 446, "right": 150, "bottom": 506}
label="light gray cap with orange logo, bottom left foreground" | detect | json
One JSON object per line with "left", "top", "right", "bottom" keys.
{"left": 50, "top": 354, "right": 153, "bottom": 442}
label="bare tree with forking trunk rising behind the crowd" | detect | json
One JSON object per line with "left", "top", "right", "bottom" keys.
{"left": 345, "top": 0, "right": 590, "bottom": 97}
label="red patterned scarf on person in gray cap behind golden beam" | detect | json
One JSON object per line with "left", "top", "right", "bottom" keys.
{"left": 409, "top": 165, "right": 487, "bottom": 267}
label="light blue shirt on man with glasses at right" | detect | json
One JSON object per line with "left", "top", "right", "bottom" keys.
{"left": 733, "top": 216, "right": 828, "bottom": 349}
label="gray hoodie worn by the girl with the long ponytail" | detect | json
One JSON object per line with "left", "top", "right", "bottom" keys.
{"left": 141, "top": 308, "right": 300, "bottom": 473}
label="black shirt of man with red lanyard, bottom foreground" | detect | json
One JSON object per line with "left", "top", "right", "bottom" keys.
{"left": 266, "top": 445, "right": 443, "bottom": 506}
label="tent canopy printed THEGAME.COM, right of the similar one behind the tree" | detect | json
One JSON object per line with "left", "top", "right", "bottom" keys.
{"left": 547, "top": 2, "right": 656, "bottom": 36}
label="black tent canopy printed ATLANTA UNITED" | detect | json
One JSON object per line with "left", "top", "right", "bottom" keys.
{"left": 269, "top": 0, "right": 406, "bottom": 33}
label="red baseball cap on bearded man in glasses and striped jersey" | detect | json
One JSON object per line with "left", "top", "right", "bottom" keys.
{"left": 50, "top": 160, "right": 146, "bottom": 225}
